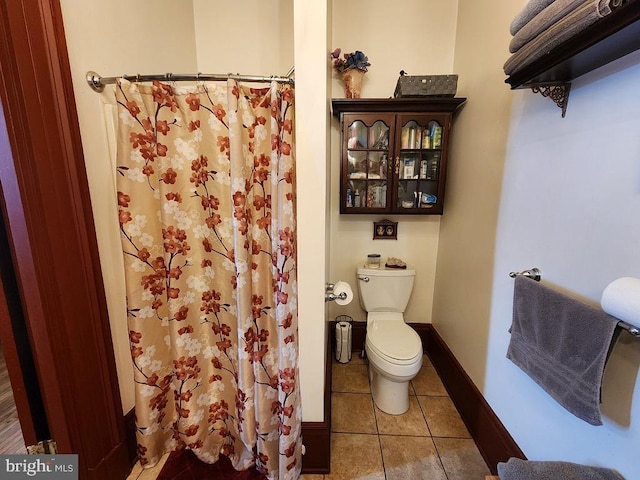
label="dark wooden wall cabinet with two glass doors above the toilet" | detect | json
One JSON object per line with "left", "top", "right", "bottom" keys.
{"left": 332, "top": 97, "right": 466, "bottom": 215}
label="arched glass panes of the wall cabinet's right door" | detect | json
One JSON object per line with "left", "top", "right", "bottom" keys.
{"left": 394, "top": 116, "right": 443, "bottom": 212}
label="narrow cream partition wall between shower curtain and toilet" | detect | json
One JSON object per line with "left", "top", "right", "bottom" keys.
{"left": 294, "top": 0, "right": 329, "bottom": 422}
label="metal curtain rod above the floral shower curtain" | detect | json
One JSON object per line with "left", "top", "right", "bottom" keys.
{"left": 86, "top": 67, "right": 295, "bottom": 92}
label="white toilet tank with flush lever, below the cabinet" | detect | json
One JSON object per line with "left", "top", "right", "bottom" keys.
{"left": 356, "top": 267, "right": 416, "bottom": 313}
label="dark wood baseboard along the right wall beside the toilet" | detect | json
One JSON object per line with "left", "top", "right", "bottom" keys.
{"left": 418, "top": 324, "right": 526, "bottom": 474}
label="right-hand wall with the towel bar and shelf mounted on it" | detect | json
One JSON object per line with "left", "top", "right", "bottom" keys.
{"left": 434, "top": 0, "right": 640, "bottom": 480}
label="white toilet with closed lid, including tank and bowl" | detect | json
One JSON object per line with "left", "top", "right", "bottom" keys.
{"left": 357, "top": 266, "right": 422, "bottom": 415}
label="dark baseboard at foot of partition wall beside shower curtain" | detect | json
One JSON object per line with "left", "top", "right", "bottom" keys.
{"left": 302, "top": 322, "right": 335, "bottom": 475}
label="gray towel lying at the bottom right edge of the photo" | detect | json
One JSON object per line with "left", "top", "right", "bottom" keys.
{"left": 498, "top": 458, "right": 624, "bottom": 480}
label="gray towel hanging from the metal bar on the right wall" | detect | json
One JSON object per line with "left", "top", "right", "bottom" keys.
{"left": 507, "top": 276, "right": 618, "bottom": 425}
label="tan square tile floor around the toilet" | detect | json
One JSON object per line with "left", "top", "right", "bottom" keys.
{"left": 128, "top": 355, "right": 490, "bottom": 480}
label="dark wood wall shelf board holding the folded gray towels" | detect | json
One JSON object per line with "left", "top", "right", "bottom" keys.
{"left": 505, "top": 0, "right": 640, "bottom": 89}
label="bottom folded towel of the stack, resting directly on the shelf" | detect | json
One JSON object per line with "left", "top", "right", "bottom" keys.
{"left": 504, "top": 0, "right": 611, "bottom": 75}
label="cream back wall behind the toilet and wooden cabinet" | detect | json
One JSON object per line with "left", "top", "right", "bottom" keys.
{"left": 327, "top": 0, "right": 457, "bottom": 323}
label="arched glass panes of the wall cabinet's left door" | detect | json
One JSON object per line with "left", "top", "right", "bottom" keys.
{"left": 342, "top": 116, "right": 391, "bottom": 209}
